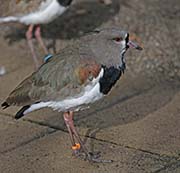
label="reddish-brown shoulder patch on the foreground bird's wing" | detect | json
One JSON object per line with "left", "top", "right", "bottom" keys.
{"left": 76, "top": 62, "right": 101, "bottom": 84}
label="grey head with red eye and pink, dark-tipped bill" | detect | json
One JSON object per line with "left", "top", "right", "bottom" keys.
{"left": 81, "top": 28, "right": 142, "bottom": 72}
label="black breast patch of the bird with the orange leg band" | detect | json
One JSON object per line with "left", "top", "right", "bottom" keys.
{"left": 99, "top": 66, "right": 121, "bottom": 94}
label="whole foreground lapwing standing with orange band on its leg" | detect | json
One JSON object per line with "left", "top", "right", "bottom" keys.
{"left": 1, "top": 27, "right": 142, "bottom": 162}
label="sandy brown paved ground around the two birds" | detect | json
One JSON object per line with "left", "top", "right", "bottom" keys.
{"left": 0, "top": 0, "right": 180, "bottom": 173}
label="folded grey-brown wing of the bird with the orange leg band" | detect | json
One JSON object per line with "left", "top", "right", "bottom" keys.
{"left": 6, "top": 45, "right": 101, "bottom": 106}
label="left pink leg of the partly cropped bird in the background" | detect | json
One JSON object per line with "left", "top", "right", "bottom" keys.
{"left": 26, "top": 25, "right": 39, "bottom": 68}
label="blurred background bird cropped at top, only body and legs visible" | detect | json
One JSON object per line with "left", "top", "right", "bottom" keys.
{"left": 0, "top": 0, "right": 72, "bottom": 68}
